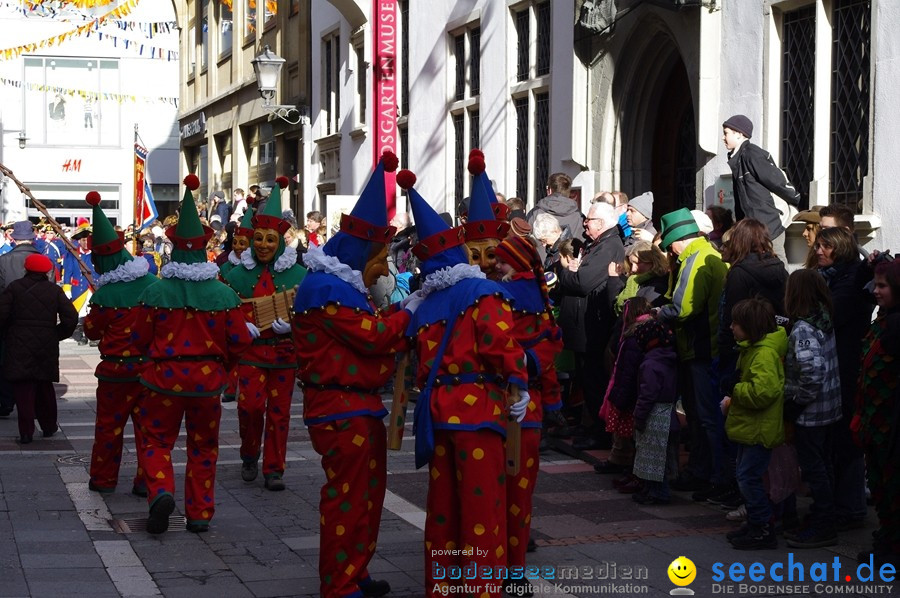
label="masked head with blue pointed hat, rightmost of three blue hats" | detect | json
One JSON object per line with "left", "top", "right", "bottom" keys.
{"left": 464, "top": 149, "right": 509, "bottom": 280}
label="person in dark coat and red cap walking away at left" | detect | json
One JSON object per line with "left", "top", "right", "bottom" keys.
{"left": 0, "top": 253, "right": 78, "bottom": 444}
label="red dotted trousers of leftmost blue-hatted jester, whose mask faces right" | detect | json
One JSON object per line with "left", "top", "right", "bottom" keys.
{"left": 309, "top": 416, "right": 387, "bottom": 598}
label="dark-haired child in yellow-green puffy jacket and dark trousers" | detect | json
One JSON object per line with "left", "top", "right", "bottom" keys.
{"left": 722, "top": 299, "right": 787, "bottom": 550}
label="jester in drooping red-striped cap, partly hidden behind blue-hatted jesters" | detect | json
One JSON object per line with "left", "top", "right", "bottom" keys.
{"left": 492, "top": 236, "right": 562, "bottom": 596}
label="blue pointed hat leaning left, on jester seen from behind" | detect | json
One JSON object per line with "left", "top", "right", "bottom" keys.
{"left": 397, "top": 170, "right": 469, "bottom": 276}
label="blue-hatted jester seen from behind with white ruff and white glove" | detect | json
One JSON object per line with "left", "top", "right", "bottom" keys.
{"left": 397, "top": 171, "right": 531, "bottom": 596}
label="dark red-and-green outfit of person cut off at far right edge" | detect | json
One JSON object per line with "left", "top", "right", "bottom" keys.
{"left": 851, "top": 304, "right": 900, "bottom": 566}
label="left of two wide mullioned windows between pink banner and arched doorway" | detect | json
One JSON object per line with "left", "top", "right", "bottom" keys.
{"left": 449, "top": 21, "right": 481, "bottom": 211}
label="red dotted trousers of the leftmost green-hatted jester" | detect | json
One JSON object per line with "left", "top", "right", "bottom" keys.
{"left": 91, "top": 380, "right": 146, "bottom": 490}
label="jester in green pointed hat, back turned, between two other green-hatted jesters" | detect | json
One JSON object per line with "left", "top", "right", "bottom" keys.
{"left": 133, "top": 174, "right": 251, "bottom": 534}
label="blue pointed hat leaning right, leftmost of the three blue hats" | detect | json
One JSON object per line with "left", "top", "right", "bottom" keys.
{"left": 322, "top": 151, "right": 399, "bottom": 272}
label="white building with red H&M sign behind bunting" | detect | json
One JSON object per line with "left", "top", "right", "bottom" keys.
{"left": 0, "top": 2, "right": 179, "bottom": 226}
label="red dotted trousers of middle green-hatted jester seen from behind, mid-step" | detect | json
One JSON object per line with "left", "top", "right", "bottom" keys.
{"left": 140, "top": 390, "right": 222, "bottom": 523}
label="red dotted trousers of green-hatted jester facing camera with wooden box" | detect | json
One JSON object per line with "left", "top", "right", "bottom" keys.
{"left": 237, "top": 364, "right": 297, "bottom": 476}
